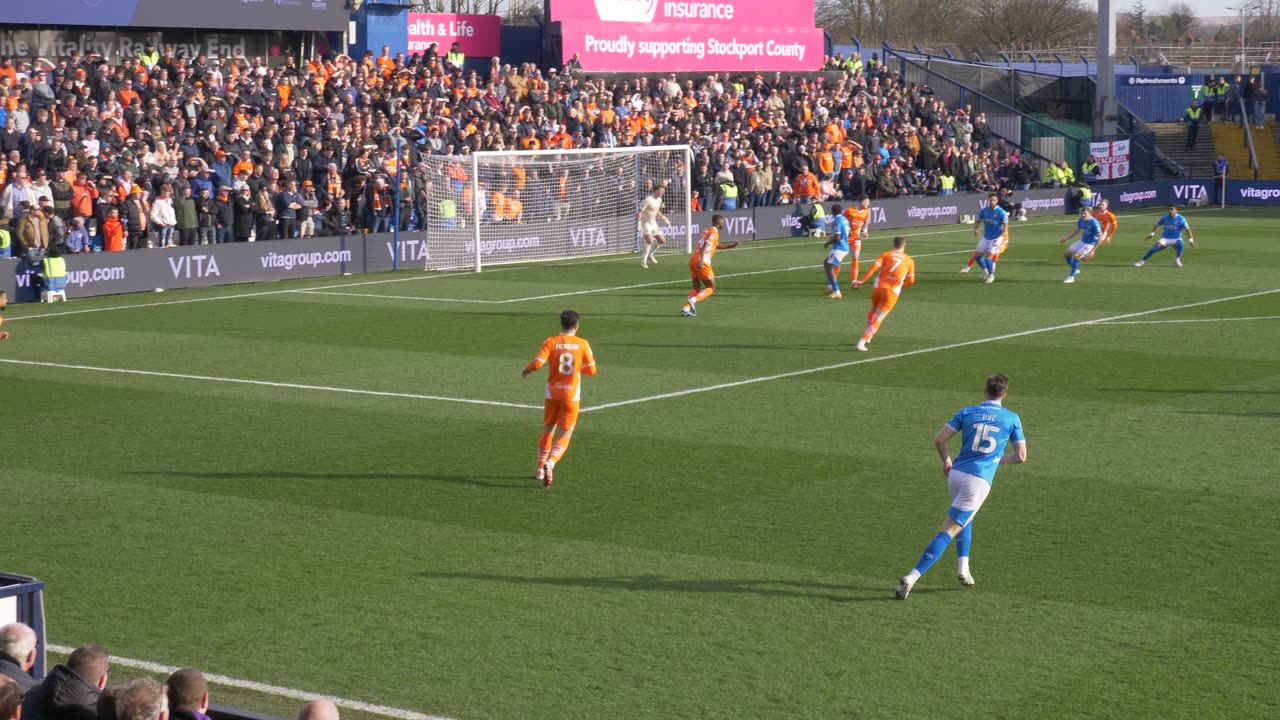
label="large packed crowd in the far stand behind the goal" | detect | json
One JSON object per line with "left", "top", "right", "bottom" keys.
{"left": 0, "top": 40, "right": 1059, "bottom": 254}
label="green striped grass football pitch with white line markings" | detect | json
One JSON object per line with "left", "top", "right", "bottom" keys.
{"left": 0, "top": 209, "right": 1280, "bottom": 720}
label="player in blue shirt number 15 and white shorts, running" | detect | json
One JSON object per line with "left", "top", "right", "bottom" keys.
{"left": 896, "top": 374, "right": 1027, "bottom": 600}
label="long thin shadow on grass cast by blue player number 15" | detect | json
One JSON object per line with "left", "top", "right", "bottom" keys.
{"left": 419, "top": 570, "right": 964, "bottom": 602}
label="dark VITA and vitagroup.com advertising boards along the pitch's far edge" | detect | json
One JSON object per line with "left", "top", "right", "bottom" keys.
{"left": 0, "top": 181, "right": 1254, "bottom": 302}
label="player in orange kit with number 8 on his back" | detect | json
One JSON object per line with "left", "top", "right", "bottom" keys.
{"left": 521, "top": 310, "right": 595, "bottom": 487}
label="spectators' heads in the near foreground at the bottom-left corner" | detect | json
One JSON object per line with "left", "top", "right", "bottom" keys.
{"left": 0, "top": 623, "right": 339, "bottom": 720}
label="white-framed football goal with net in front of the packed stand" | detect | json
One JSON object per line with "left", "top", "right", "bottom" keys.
{"left": 417, "top": 145, "right": 694, "bottom": 272}
